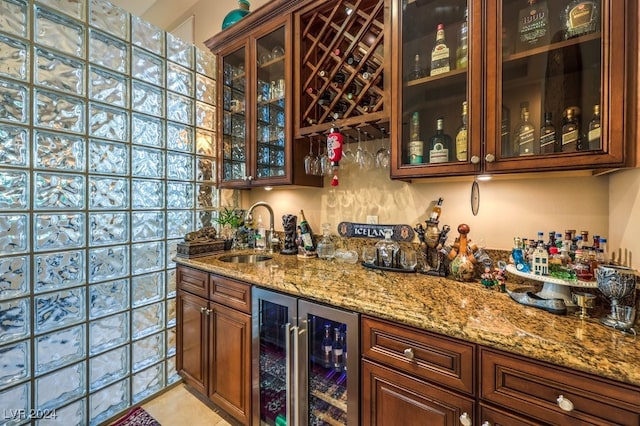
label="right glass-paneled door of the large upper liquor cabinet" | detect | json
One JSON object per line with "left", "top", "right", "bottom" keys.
{"left": 484, "top": 0, "right": 637, "bottom": 172}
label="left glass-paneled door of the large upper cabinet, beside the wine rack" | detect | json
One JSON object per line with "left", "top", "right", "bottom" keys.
{"left": 391, "top": 0, "right": 482, "bottom": 179}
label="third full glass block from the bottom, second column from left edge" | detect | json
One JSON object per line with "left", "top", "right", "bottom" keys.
{"left": 33, "top": 287, "right": 87, "bottom": 333}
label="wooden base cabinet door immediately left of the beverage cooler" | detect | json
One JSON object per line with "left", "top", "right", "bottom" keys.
{"left": 208, "top": 303, "right": 251, "bottom": 424}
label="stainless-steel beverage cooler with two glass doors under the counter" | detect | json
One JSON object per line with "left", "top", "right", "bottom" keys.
{"left": 252, "top": 289, "right": 360, "bottom": 426}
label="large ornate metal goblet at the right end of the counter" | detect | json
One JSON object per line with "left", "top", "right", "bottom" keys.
{"left": 596, "top": 266, "right": 636, "bottom": 328}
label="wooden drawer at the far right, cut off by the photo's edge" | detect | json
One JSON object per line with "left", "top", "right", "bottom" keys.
{"left": 480, "top": 348, "right": 640, "bottom": 426}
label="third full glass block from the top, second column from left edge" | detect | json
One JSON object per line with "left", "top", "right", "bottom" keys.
{"left": 34, "top": 89, "right": 85, "bottom": 133}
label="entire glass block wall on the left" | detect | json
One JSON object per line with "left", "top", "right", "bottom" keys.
{"left": 0, "top": 0, "right": 218, "bottom": 426}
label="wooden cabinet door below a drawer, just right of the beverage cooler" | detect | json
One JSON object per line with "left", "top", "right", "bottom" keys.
{"left": 362, "top": 361, "right": 474, "bottom": 426}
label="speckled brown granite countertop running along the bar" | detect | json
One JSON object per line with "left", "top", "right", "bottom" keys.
{"left": 175, "top": 253, "right": 640, "bottom": 385}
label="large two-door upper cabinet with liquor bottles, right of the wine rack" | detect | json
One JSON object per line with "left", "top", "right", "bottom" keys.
{"left": 391, "top": 0, "right": 637, "bottom": 179}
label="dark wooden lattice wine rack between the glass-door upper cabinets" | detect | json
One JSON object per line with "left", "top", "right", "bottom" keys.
{"left": 296, "top": 0, "right": 389, "bottom": 137}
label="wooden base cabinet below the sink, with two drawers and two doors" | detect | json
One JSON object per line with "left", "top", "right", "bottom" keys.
{"left": 176, "top": 266, "right": 251, "bottom": 424}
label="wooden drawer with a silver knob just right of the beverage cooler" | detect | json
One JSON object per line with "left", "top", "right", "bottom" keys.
{"left": 362, "top": 316, "right": 476, "bottom": 394}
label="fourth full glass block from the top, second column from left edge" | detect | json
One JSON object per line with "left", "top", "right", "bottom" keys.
{"left": 33, "top": 130, "right": 86, "bottom": 172}
